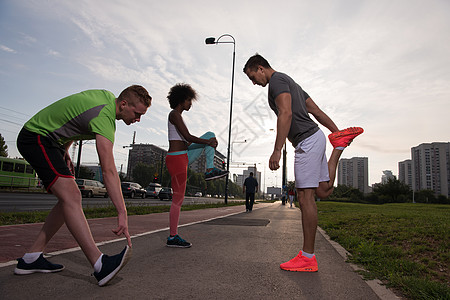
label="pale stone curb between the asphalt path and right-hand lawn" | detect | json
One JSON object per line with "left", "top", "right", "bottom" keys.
{"left": 317, "top": 227, "right": 401, "bottom": 300}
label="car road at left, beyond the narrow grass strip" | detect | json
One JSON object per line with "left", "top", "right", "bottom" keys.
{"left": 0, "top": 193, "right": 234, "bottom": 212}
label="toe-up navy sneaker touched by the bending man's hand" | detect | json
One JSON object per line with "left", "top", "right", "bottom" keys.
{"left": 94, "top": 245, "right": 131, "bottom": 286}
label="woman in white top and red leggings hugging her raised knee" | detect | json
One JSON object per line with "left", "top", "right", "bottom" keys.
{"left": 166, "top": 83, "right": 228, "bottom": 248}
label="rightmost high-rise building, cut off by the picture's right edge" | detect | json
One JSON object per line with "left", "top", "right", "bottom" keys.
{"left": 411, "top": 142, "right": 450, "bottom": 197}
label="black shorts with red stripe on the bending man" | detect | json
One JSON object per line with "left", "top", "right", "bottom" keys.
{"left": 17, "top": 128, "right": 74, "bottom": 191}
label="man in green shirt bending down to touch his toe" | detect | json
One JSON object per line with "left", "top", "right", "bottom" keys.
{"left": 14, "top": 85, "right": 152, "bottom": 286}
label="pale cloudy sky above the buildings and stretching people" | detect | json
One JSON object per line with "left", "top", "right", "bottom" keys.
{"left": 0, "top": 0, "right": 450, "bottom": 187}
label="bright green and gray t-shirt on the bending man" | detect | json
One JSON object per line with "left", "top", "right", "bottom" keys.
{"left": 24, "top": 90, "right": 116, "bottom": 145}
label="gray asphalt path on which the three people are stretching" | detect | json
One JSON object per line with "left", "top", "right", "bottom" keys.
{"left": 0, "top": 203, "right": 395, "bottom": 300}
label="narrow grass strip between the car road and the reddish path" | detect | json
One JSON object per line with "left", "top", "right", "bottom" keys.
{"left": 0, "top": 201, "right": 245, "bottom": 226}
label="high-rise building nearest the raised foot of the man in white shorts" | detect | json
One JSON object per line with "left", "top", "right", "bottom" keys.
{"left": 338, "top": 157, "right": 369, "bottom": 194}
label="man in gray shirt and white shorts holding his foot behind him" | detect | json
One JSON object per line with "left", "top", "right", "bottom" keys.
{"left": 244, "top": 54, "right": 363, "bottom": 272}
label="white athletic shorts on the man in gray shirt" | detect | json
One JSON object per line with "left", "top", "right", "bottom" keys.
{"left": 294, "top": 129, "right": 330, "bottom": 188}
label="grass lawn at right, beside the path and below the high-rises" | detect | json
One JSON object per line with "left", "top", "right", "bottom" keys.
{"left": 317, "top": 201, "right": 450, "bottom": 299}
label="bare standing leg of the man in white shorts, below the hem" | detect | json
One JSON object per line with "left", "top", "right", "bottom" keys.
{"left": 297, "top": 189, "right": 317, "bottom": 254}
